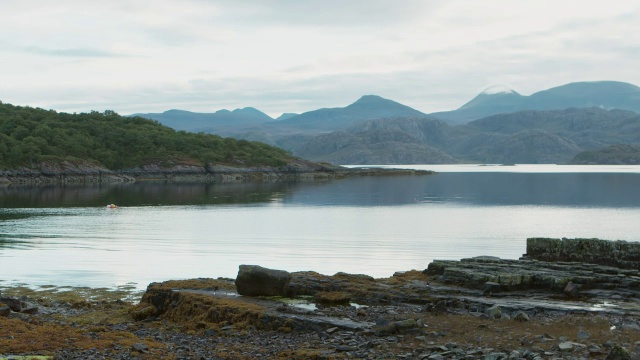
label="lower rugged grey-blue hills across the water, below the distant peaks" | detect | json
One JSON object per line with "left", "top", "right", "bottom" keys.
{"left": 292, "top": 108, "right": 640, "bottom": 164}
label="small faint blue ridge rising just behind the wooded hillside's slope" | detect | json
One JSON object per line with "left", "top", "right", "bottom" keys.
{"left": 134, "top": 107, "right": 273, "bottom": 132}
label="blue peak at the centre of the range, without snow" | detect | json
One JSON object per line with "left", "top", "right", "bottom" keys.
{"left": 279, "top": 95, "right": 426, "bottom": 131}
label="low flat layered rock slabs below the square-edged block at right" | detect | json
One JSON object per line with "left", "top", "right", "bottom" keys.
{"left": 424, "top": 257, "right": 640, "bottom": 314}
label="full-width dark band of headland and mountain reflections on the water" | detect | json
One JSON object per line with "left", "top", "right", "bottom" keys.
{"left": 0, "top": 172, "right": 640, "bottom": 208}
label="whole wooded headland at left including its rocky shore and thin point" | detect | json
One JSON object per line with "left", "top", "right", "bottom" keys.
{"left": 0, "top": 103, "right": 432, "bottom": 185}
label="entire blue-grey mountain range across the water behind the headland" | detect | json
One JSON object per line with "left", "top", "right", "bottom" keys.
{"left": 137, "top": 81, "right": 640, "bottom": 164}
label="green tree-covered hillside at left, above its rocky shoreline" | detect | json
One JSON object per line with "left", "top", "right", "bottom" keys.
{"left": 0, "top": 102, "right": 292, "bottom": 170}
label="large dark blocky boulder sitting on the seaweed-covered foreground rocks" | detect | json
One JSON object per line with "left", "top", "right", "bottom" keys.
{"left": 236, "top": 265, "right": 291, "bottom": 296}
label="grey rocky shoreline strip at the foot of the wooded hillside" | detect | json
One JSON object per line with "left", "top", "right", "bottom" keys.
{"left": 0, "top": 160, "right": 433, "bottom": 185}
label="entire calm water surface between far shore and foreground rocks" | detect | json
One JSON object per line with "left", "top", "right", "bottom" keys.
{"left": 0, "top": 165, "right": 640, "bottom": 288}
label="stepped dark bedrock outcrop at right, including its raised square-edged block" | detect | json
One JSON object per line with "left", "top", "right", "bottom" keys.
{"left": 424, "top": 238, "right": 640, "bottom": 296}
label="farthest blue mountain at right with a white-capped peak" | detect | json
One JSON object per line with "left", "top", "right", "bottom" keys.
{"left": 429, "top": 81, "right": 640, "bottom": 125}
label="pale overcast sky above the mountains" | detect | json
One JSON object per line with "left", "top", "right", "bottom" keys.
{"left": 0, "top": 0, "right": 640, "bottom": 117}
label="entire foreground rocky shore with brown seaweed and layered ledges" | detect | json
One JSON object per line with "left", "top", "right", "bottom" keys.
{"left": 0, "top": 238, "right": 640, "bottom": 360}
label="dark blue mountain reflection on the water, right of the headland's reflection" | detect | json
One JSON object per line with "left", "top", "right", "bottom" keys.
{"left": 285, "top": 172, "right": 640, "bottom": 207}
